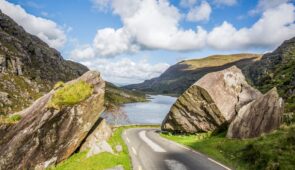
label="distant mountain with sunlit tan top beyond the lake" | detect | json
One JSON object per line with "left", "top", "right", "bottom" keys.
{"left": 124, "top": 54, "right": 261, "bottom": 96}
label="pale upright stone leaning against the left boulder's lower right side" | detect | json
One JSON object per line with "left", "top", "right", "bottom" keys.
{"left": 80, "top": 118, "right": 112, "bottom": 151}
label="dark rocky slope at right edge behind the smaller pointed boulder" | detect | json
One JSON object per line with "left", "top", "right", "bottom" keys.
{"left": 243, "top": 37, "right": 295, "bottom": 112}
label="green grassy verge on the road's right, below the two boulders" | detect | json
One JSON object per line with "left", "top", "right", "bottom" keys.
{"left": 161, "top": 125, "right": 295, "bottom": 170}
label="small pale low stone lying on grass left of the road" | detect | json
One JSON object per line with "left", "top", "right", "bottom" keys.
{"left": 86, "top": 141, "right": 114, "bottom": 158}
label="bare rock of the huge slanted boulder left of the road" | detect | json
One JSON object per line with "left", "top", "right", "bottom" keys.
{"left": 0, "top": 71, "right": 105, "bottom": 170}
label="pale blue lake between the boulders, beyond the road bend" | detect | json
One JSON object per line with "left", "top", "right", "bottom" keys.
{"left": 102, "top": 95, "right": 177, "bottom": 125}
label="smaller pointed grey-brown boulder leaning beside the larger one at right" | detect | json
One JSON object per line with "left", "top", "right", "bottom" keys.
{"left": 227, "top": 88, "right": 284, "bottom": 138}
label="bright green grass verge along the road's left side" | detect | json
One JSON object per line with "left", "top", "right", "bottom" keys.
{"left": 52, "top": 126, "right": 158, "bottom": 170}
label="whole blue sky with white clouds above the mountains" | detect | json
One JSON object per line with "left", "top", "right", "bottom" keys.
{"left": 0, "top": 0, "right": 295, "bottom": 84}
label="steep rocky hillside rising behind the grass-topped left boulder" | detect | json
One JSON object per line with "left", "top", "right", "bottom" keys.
{"left": 0, "top": 11, "right": 88, "bottom": 114}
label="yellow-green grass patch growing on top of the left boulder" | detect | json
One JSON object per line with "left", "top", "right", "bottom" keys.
{"left": 48, "top": 81, "right": 93, "bottom": 108}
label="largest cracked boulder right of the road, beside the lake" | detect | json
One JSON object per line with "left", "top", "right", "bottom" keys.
{"left": 162, "top": 66, "right": 261, "bottom": 133}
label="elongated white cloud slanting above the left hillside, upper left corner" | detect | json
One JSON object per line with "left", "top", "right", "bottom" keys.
{"left": 0, "top": 0, "right": 67, "bottom": 48}
